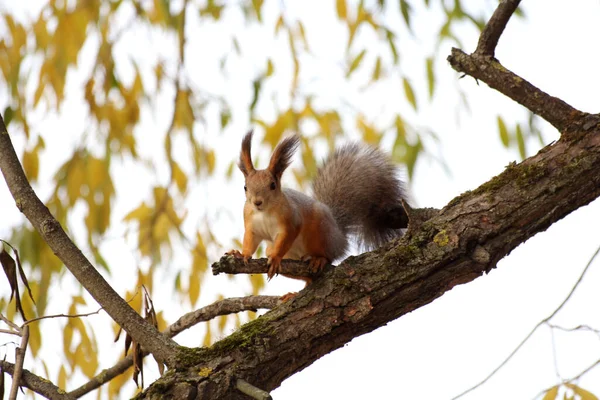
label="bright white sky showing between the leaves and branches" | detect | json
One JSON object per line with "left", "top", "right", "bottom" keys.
{"left": 0, "top": 0, "right": 600, "bottom": 400}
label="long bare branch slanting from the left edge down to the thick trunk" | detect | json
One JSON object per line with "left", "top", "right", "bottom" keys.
{"left": 0, "top": 116, "right": 178, "bottom": 366}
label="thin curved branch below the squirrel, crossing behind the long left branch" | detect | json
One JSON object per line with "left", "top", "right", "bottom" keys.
{"left": 69, "top": 296, "right": 281, "bottom": 398}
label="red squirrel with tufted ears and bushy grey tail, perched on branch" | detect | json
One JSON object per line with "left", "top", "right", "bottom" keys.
{"left": 228, "top": 131, "right": 408, "bottom": 285}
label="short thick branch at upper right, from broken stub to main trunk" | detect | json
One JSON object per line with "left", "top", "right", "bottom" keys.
{"left": 448, "top": 48, "right": 584, "bottom": 133}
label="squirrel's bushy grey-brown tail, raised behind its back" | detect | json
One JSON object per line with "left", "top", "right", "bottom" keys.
{"left": 313, "top": 144, "right": 408, "bottom": 250}
